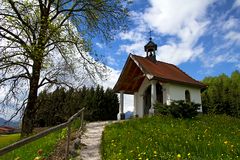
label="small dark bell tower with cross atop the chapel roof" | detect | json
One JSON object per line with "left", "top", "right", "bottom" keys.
{"left": 144, "top": 31, "right": 157, "bottom": 62}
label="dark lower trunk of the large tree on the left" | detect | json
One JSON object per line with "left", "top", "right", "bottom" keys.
{"left": 21, "top": 62, "right": 41, "bottom": 137}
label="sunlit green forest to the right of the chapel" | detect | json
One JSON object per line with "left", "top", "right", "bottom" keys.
{"left": 202, "top": 71, "right": 240, "bottom": 117}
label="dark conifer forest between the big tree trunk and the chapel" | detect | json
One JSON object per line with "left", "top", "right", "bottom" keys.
{"left": 34, "top": 85, "right": 119, "bottom": 127}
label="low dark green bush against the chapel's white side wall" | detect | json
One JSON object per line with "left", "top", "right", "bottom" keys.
{"left": 155, "top": 100, "right": 200, "bottom": 118}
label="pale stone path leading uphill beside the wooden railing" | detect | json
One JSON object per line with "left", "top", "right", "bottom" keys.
{"left": 76, "top": 121, "right": 111, "bottom": 160}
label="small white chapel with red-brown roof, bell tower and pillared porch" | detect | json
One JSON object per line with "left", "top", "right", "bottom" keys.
{"left": 114, "top": 38, "right": 206, "bottom": 120}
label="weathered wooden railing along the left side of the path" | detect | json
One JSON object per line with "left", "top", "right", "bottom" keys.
{"left": 0, "top": 108, "right": 85, "bottom": 159}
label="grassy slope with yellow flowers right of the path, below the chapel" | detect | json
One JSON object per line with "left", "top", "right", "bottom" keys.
{"left": 101, "top": 115, "right": 240, "bottom": 160}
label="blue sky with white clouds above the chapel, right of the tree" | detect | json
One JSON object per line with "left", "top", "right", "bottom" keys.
{"left": 95, "top": 0, "right": 240, "bottom": 80}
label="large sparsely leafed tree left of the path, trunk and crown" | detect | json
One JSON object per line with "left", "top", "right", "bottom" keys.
{"left": 0, "top": 0, "right": 127, "bottom": 136}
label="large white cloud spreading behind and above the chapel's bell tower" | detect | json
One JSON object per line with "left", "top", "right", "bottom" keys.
{"left": 117, "top": 0, "right": 214, "bottom": 64}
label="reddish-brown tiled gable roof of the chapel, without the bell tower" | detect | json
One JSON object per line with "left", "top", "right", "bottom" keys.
{"left": 114, "top": 54, "right": 206, "bottom": 94}
